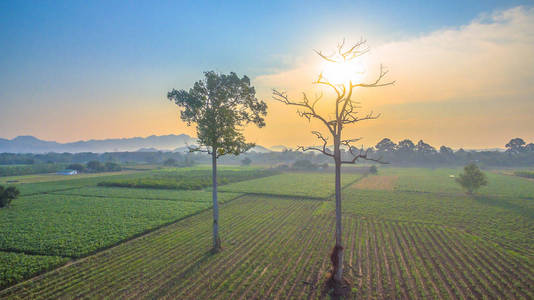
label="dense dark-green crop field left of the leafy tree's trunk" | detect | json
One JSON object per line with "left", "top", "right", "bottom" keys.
{"left": 0, "top": 166, "right": 255, "bottom": 287}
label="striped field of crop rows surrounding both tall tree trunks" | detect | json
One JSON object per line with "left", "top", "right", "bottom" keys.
{"left": 0, "top": 197, "right": 534, "bottom": 299}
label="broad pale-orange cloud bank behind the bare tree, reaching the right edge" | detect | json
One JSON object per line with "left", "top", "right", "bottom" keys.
{"left": 254, "top": 6, "right": 534, "bottom": 147}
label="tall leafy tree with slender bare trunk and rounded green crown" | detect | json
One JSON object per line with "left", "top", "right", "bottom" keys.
{"left": 167, "top": 71, "right": 267, "bottom": 252}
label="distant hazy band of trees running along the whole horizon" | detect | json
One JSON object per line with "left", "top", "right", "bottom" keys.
{"left": 0, "top": 138, "right": 534, "bottom": 168}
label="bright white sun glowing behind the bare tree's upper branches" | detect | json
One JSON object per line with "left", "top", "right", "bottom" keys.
{"left": 322, "top": 59, "right": 366, "bottom": 85}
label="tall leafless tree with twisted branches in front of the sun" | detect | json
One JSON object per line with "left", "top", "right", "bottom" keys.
{"left": 273, "top": 40, "right": 394, "bottom": 295}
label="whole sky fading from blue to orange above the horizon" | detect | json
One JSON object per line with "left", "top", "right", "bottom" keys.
{"left": 0, "top": 0, "right": 534, "bottom": 148}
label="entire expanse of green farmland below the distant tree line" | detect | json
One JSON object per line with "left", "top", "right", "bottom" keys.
{"left": 0, "top": 167, "right": 534, "bottom": 299}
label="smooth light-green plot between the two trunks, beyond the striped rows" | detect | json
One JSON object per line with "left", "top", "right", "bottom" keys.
{"left": 219, "top": 173, "right": 363, "bottom": 198}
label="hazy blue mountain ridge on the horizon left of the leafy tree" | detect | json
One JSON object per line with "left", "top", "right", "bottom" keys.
{"left": 0, "top": 134, "right": 196, "bottom": 153}
